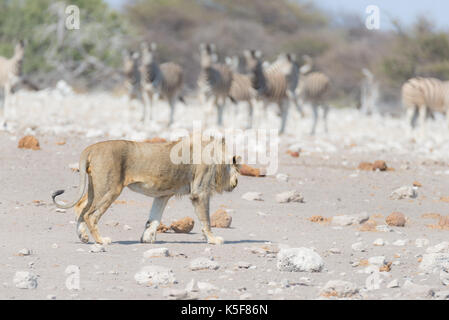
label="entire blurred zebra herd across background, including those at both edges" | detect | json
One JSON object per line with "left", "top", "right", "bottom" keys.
{"left": 0, "top": 41, "right": 449, "bottom": 135}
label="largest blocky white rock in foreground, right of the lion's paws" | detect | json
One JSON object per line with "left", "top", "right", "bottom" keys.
{"left": 277, "top": 248, "right": 324, "bottom": 272}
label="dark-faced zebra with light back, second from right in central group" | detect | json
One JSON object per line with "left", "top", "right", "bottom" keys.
{"left": 244, "top": 50, "right": 291, "bottom": 134}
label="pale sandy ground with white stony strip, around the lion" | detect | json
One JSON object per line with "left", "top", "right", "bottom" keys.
{"left": 0, "top": 85, "right": 449, "bottom": 299}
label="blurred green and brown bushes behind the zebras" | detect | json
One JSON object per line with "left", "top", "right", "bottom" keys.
{"left": 0, "top": 0, "right": 449, "bottom": 106}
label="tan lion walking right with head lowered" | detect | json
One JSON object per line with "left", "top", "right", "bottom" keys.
{"left": 52, "top": 137, "right": 241, "bottom": 244}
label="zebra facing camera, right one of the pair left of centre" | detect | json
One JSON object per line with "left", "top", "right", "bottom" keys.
{"left": 140, "top": 42, "right": 184, "bottom": 126}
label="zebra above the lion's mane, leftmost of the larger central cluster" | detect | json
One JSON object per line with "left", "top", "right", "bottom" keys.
{"left": 198, "top": 43, "right": 233, "bottom": 126}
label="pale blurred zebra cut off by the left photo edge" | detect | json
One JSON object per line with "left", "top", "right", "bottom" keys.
{"left": 0, "top": 41, "right": 25, "bottom": 126}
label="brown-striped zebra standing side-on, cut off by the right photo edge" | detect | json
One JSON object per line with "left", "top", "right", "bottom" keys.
{"left": 401, "top": 77, "right": 449, "bottom": 130}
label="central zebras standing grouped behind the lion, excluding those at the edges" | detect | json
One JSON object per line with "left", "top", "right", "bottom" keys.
{"left": 124, "top": 43, "right": 330, "bottom": 134}
